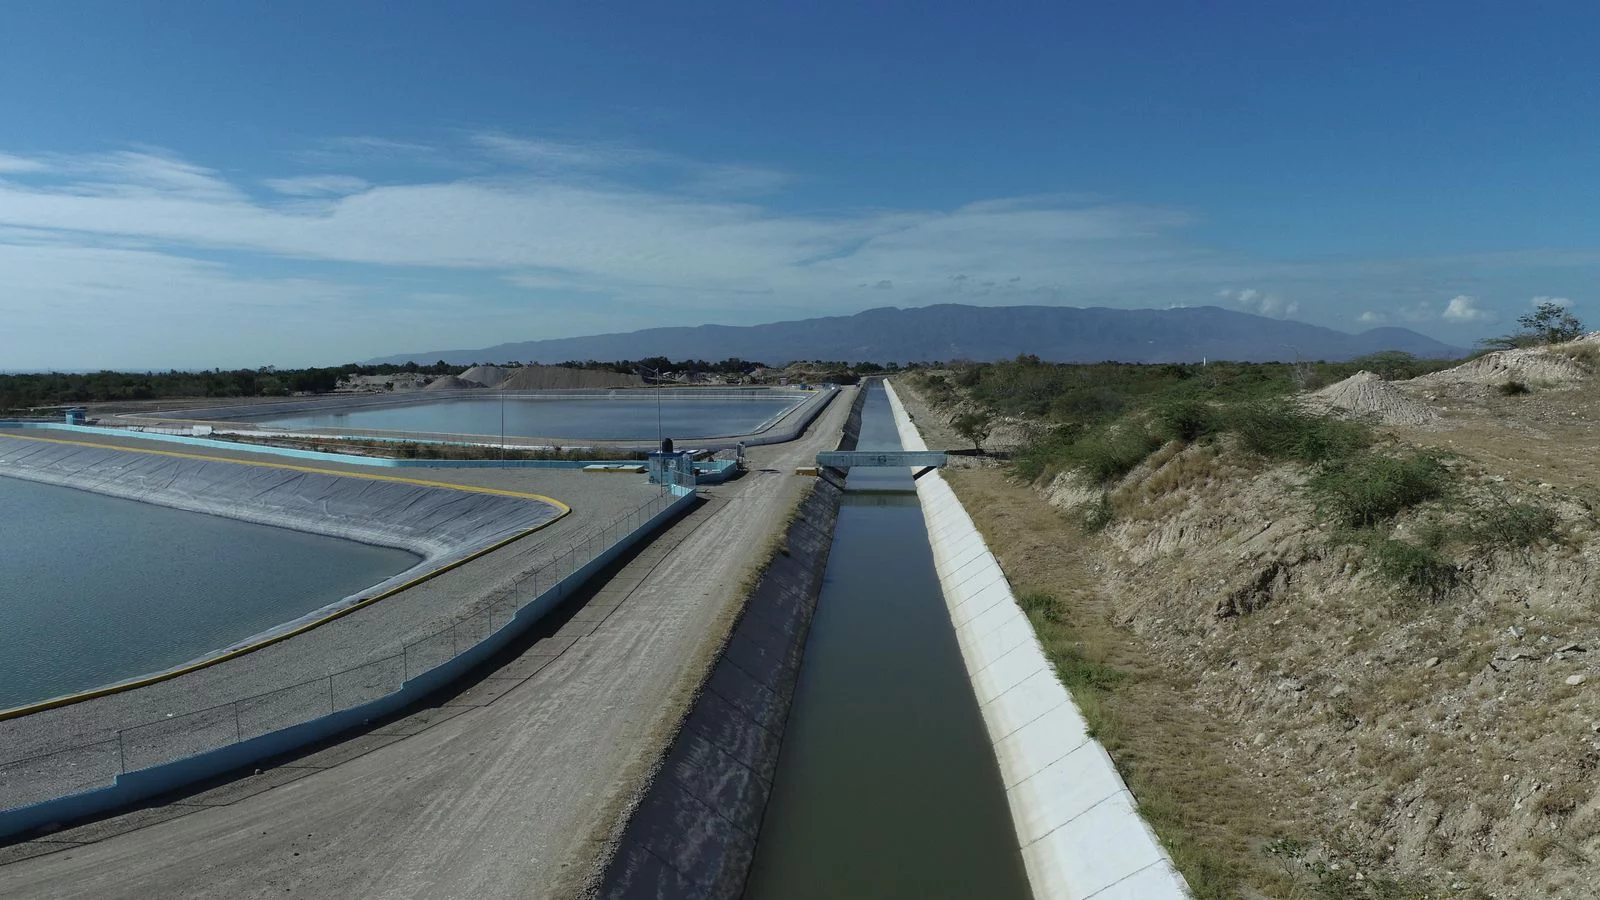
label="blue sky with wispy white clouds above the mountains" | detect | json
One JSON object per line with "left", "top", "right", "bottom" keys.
{"left": 0, "top": 0, "right": 1600, "bottom": 370}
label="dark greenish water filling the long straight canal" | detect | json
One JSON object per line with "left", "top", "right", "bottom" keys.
{"left": 744, "top": 388, "right": 1029, "bottom": 900}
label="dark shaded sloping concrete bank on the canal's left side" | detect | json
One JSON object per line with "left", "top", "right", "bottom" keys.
{"left": 600, "top": 381, "right": 867, "bottom": 900}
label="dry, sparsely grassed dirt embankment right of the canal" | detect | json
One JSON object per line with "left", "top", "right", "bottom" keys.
{"left": 914, "top": 354, "right": 1600, "bottom": 900}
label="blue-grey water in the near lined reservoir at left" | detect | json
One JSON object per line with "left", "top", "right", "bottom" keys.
{"left": 0, "top": 477, "right": 418, "bottom": 709}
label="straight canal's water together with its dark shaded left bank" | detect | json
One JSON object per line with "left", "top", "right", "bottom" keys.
{"left": 602, "top": 379, "right": 1029, "bottom": 900}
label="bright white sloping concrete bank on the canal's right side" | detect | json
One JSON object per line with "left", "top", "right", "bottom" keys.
{"left": 885, "top": 383, "right": 1189, "bottom": 900}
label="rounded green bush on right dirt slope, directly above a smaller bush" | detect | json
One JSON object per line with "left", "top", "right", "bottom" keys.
{"left": 1306, "top": 452, "right": 1450, "bottom": 528}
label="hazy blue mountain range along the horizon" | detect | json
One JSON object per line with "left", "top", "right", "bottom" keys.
{"left": 370, "top": 304, "right": 1467, "bottom": 365}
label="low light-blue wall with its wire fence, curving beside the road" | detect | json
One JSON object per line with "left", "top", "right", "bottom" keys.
{"left": 0, "top": 485, "right": 696, "bottom": 839}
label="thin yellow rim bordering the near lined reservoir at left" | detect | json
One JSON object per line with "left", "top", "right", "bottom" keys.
{"left": 0, "top": 434, "right": 573, "bottom": 722}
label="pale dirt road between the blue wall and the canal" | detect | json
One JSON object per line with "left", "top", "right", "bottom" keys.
{"left": 0, "top": 391, "right": 853, "bottom": 900}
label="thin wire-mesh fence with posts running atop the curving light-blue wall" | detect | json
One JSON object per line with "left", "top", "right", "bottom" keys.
{"left": 0, "top": 487, "right": 693, "bottom": 812}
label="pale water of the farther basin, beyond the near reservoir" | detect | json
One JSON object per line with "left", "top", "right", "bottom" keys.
{"left": 250, "top": 394, "right": 802, "bottom": 440}
